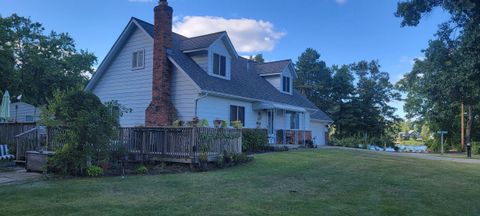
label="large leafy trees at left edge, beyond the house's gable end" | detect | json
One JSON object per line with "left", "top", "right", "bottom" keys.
{"left": 0, "top": 14, "right": 96, "bottom": 105}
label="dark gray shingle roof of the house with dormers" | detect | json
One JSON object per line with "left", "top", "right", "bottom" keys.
{"left": 136, "top": 19, "right": 331, "bottom": 120}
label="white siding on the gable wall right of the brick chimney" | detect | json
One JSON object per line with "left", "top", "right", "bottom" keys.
{"left": 172, "top": 67, "right": 200, "bottom": 121}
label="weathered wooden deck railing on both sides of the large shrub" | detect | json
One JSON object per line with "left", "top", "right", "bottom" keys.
{"left": 16, "top": 127, "right": 242, "bottom": 163}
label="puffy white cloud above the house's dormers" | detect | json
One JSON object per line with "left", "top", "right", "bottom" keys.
{"left": 173, "top": 16, "right": 286, "bottom": 53}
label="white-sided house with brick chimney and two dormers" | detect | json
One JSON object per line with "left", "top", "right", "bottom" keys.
{"left": 86, "top": 0, "right": 332, "bottom": 145}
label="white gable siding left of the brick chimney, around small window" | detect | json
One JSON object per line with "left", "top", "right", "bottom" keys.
{"left": 92, "top": 29, "right": 153, "bottom": 127}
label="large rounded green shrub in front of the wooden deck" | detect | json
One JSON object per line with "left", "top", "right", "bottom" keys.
{"left": 42, "top": 91, "right": 121, "bottom": 175}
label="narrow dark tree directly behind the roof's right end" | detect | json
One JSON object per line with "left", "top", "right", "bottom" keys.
{"left": 294, "top": 48, "right": 332, "bottom": 113}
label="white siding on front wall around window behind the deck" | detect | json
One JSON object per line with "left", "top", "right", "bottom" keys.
{"left": 197, "top": 96, "right": 258, "bottom": 128}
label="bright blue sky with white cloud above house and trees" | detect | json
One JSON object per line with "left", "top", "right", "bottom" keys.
{"left": 0, "top": 0, "right": 448, "bottom": 116}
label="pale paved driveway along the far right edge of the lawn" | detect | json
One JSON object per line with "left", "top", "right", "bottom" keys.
{"left": 322, "top": 146, "right": 480, "bottom": 164}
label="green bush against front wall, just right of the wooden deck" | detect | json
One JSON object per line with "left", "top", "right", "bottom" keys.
{"left": 242, "top": 129, "right": 268, "bottom": 152}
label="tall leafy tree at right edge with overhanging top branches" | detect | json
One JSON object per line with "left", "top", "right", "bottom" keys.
{"left": 395, "top": 0, "right": 480, "bottom": 147}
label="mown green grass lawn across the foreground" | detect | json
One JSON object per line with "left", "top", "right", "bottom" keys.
{"left": 0, "top": 149, "right": 480, "bottom": 216}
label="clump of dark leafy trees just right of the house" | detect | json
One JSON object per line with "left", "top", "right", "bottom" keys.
{"left": 295, "top": 48, "right": 399, "bottom": 137}
